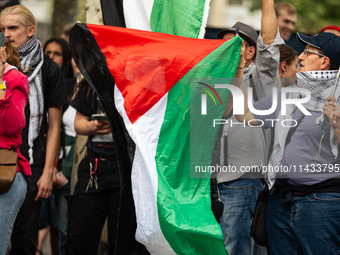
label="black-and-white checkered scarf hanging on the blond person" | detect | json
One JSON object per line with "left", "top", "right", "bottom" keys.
{"left": 17, "top": 36, "right": 44, "bottom": 164}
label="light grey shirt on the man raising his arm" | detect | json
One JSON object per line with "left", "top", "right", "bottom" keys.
{"left": 217, "top": 28, "right": 284, "bottom": 183}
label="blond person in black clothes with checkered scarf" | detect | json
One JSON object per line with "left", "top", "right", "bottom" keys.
{"left": 0, "top": 5, "right": 67, "bottom": 255}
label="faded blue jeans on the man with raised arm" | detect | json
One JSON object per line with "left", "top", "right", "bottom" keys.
{"left": 219, "top": 178, "right": 267, "bottom": 255}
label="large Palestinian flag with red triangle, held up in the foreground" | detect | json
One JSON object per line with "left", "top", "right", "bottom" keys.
{"left": 70, "top": 24, "right": 242, "bottom": 255}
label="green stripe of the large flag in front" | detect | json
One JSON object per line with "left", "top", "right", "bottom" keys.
{"left": 156, "top": 37, "right": 242, "bottom": 255}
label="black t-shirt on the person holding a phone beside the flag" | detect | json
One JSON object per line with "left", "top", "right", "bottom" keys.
{"left": 71, "top": 83, "right": 116, "bottom": 156}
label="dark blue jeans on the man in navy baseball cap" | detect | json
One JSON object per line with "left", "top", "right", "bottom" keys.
{"left": 266, "top": 187, "right": 340, "bottom": 255}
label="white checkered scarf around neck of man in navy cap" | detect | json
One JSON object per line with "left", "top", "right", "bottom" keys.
{"left": 268, "top": 70, "right": 340, "bottom": 188}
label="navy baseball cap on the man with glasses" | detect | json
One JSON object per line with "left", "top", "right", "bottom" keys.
{"left": 296, "top": 33, "right": 340, "bottom": 66}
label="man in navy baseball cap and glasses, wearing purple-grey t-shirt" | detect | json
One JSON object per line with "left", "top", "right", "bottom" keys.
{"left": 231, "top": 33, "right": 340, "bottom": 255}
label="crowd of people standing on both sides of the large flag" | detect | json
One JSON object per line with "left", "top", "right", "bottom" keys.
{"left": 0, "top": 0, "right": 340, "bottom": 255}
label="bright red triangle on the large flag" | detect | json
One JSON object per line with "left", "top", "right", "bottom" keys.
{"left": 87, "top": 24, "right": 225, "bottom": 124}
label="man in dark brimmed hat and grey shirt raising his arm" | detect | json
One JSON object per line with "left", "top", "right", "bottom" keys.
{"left": 217, "top": 0, "right": 284, "bottom": 255}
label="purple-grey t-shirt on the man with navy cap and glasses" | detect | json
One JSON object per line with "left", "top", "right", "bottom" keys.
{"left": 253, "top": 91, "right": 340, "bottom": 186}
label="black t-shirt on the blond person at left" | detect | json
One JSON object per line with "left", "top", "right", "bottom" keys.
{"left": 20, "top": 55, "right": 68, "bottom": 176}
